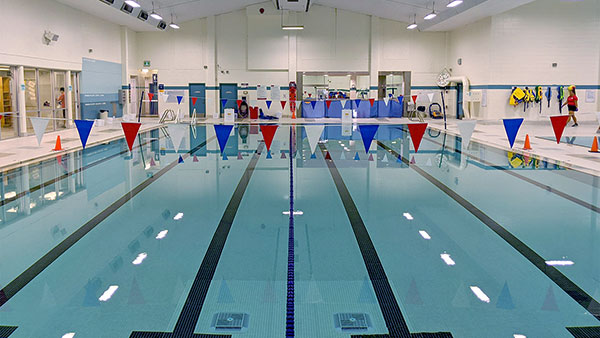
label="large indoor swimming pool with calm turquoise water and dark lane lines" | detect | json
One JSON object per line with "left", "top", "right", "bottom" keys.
{"left": 0, "top": 124, "right": 600, "bottom": 338}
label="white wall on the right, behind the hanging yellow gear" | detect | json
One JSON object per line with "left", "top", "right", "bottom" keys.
{"left": 448, "top": 0, "right": 600, "bottom": 120}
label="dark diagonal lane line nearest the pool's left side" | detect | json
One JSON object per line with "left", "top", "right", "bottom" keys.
{"left": 0, "top": 136, "right": 216, "bottom": 308}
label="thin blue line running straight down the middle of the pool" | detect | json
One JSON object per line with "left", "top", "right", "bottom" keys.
{"left": 285, "top": 126, "right": 295, "bottom": 337}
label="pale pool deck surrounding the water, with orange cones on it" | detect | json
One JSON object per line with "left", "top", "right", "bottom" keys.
{"left": 0, "top": 117, "right": 600, "bottom": 176}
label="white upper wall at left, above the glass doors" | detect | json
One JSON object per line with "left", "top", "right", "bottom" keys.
{"left": 0, "top": 0, "right": 121, "bottom": 70}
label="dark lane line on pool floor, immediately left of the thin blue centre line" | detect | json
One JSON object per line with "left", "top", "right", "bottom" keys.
{"left": 129, "top": 143, "right": 264, "bottom": 338}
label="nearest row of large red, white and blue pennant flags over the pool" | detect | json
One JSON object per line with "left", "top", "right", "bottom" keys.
{"left": 29, "top": 112, "right": 600, "bottom": 161}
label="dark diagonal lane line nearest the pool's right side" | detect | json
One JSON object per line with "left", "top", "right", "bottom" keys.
{"left": 377, "top": 141, "right": 600, "bottom": 320}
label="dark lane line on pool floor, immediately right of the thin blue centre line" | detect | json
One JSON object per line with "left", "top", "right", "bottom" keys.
{"left": 319, "top": 144, "right": 452, "bottom": 338}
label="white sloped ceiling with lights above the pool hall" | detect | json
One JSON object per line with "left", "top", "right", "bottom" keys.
{"left": 56, "top": 0, "right": 533, "bottom": 31}
